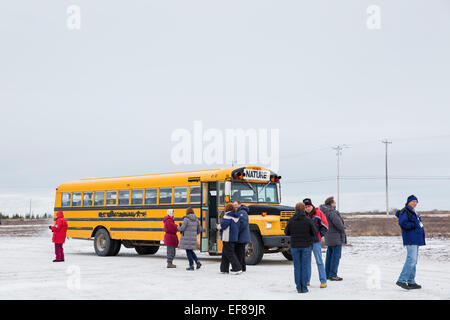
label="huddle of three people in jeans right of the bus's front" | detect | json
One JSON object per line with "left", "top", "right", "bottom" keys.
{"left": 284, "top": 197, "right": 347, "bottom": 293}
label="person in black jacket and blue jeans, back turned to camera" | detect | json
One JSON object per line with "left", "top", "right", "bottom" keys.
{"left": 284, "top": 202, "right": 318, "bottom": 293}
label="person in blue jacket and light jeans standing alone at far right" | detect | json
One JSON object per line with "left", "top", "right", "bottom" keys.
{"left": 395, "top": 195, "right": 425, "bottom": 290}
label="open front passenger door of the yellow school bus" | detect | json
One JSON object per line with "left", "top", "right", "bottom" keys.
{"left": 200, "top": 182, "right": 218, "bottom": 253}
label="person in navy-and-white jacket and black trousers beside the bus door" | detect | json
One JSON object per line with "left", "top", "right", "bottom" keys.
{"left": 217, "top": 204, "right": 242, "bottom": 274}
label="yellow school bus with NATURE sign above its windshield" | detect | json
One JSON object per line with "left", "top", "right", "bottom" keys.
{"left": 54, "top": 166, "right": 294, "bottom": 264}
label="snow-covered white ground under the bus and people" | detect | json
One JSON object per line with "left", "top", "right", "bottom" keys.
{"left": 0, "top": 226, "right": 450, "bottom": 300}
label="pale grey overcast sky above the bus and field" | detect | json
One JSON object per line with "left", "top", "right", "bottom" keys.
{"left": 0, "top": 0, "right": 450, "bottom": 213}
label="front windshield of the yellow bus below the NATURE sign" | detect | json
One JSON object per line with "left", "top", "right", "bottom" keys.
{"left": 231, "top": 182, "right": 278, "bottom": 203}
